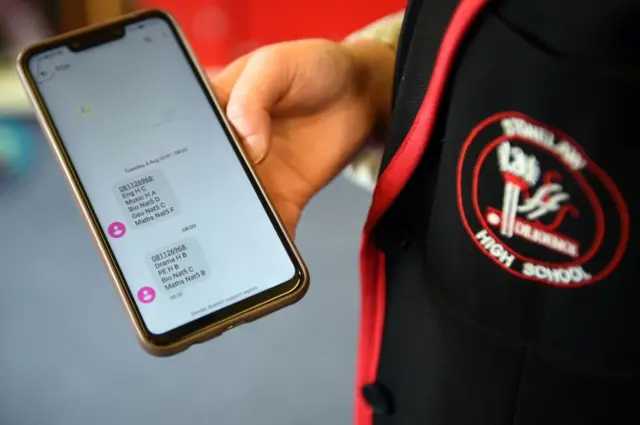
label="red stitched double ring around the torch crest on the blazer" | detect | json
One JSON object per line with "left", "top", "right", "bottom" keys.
{"left": 456, "top": 111, "right": 630, "bottom": 289}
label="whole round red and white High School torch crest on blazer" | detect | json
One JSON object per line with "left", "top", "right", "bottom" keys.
{"left": 457, "top": 112, "right": 629, "bottom": 287}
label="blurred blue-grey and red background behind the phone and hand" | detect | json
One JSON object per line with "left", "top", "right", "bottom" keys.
{"left": 0, "top": 0, "right": 405, "bottom": 425}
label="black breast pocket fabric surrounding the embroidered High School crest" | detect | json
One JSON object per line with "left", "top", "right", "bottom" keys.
{"left": 426, "top": 9, "right": 640, "bottom": 374}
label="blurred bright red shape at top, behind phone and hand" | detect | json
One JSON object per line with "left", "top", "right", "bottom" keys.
{"left": 138, "top": 0, "right": 406, "bottom": 68}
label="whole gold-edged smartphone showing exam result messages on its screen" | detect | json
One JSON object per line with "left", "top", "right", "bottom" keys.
{"left": 18, "top": 10, "right": 309, "bottom": 356}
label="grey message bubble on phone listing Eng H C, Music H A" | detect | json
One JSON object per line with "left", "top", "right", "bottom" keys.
{"left": 113, "top": 170, "right": 180, "bottom": 228}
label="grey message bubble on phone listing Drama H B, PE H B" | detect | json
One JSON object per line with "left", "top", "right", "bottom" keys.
{"left": 147, "top": 238, "right": 211, "bottom": 294}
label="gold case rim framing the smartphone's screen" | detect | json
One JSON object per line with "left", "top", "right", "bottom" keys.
{"left": 17, "top": 10, "right": 309, "bottom": 356}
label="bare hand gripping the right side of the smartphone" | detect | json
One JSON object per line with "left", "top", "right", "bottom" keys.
{"left": 212, "top": 39, "right": 395, "bottom": 234}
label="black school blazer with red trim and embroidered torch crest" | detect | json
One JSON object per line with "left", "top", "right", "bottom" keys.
{"left": 348, "top": 0, "right": 640, "bottom": 425}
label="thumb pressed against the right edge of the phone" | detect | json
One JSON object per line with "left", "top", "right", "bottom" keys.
{"left": 227, "top": 45, "right": 293, "bottom": 164}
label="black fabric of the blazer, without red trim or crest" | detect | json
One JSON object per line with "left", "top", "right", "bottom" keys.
{"left": 374, "top": 0, "right": 640, "bottom": 425}
